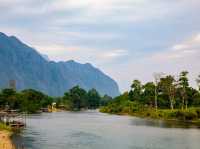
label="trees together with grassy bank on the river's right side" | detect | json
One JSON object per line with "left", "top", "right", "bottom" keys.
{"left": 100, "top": 71, "right": 200, "bottom": 125}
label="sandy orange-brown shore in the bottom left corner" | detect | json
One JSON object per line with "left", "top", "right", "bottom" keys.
{"left": 0, "top": 130, "right": 16, "bottom": 149}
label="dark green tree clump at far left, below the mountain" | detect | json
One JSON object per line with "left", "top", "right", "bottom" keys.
{"left": 0, "top": 89, "right": 53, "bottom": 113}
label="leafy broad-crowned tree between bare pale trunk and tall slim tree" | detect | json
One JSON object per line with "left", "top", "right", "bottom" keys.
{"left": 159, "top": 75, "right": 176, "bottom": 110}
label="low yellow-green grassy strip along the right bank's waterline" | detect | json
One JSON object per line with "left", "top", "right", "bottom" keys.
{"left": 100, "top": 107, "right": 200, "bottom": 127}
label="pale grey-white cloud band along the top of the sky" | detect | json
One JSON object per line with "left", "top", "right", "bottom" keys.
{"left": 0, "top": 0, "right": 200, "bottom": 23}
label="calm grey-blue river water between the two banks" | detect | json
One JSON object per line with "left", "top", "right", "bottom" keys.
{"left": 14, "top": 111, "right": 200, "bottom": 149}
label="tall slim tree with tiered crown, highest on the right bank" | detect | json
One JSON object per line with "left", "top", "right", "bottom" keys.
{"left": 179, "top": 71, "right": 189, "bottom": 110}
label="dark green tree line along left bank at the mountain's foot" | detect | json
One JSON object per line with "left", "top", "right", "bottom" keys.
{"left": 0, "top": 86, "right": 112, "bottom": 113}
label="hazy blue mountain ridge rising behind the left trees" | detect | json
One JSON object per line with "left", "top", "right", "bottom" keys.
{"left": 0, "top": 32, "right": 119, "bottom": 96}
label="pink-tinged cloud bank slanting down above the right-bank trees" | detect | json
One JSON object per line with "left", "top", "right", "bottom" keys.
{"left": 106, "top": 34, "right": 200, "bottom": 91}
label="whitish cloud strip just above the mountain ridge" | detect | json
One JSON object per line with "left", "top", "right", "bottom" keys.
{"left": 34, "top": 44, "right": 128, "bottom": 66}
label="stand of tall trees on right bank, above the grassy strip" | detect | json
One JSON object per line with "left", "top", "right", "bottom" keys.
{"left": 128, "top": 71, "right": 200, "bottom": 110}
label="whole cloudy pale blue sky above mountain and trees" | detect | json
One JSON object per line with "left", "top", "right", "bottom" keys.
{"left": 0, "top": 0, "right": 200, "bottom": 92}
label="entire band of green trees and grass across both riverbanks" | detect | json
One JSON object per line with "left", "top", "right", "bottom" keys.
{"left": 0, "top": 71, "right": 200, "bottom": 123}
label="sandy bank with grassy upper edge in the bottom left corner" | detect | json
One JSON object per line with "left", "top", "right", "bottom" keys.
{"left": 0, "top": 123, "right": 15, "bottom": 149}
